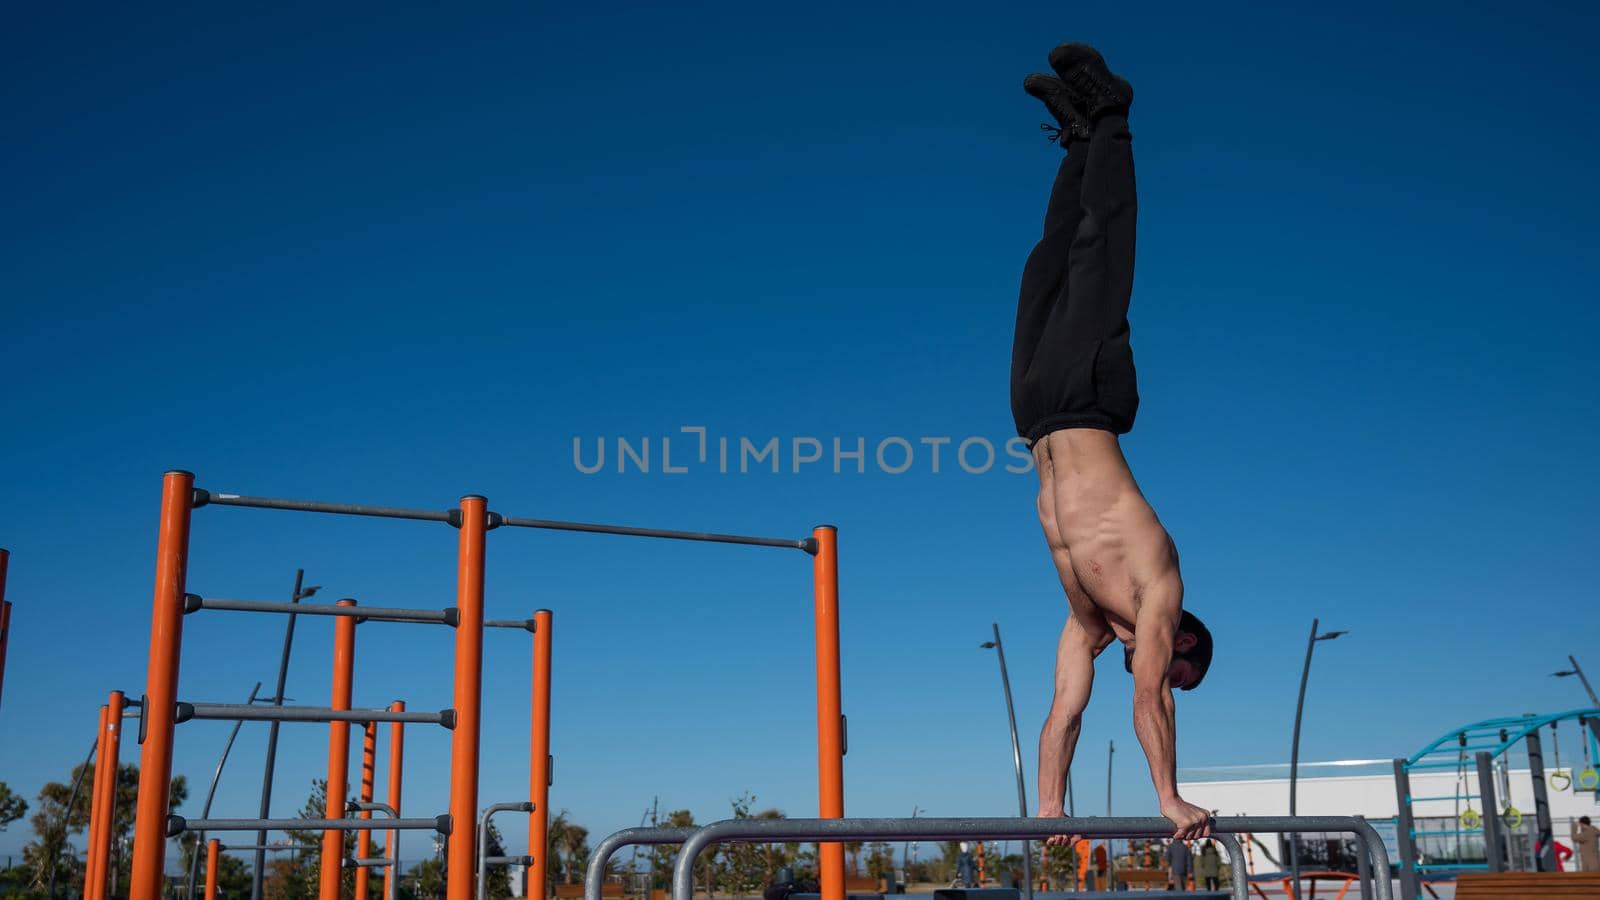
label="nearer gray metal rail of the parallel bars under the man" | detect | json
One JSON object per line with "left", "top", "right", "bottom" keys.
{"left": 672, "top": 815, "right": 1392, "bottom": 900}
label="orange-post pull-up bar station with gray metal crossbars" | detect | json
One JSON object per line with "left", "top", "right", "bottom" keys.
{"left": 130, "top": 471, "right": 845, "bottom": 900}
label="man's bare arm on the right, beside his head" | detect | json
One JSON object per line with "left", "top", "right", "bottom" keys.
{"left": 1133, "top": 572, "right": 1211, "bottom": 841}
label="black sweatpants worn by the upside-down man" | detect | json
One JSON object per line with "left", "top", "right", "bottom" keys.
{"left": 1011, "top": 115, "right": 1139, "bottom": 444}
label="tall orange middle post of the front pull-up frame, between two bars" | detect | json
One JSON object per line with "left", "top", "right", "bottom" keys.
{"left": 444, "top": 495, "right": 488, "bottom": 900}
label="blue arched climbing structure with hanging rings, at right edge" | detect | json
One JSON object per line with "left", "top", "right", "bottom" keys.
{"left": 1394, "top": 709, "right": 1600, "bottom": 900}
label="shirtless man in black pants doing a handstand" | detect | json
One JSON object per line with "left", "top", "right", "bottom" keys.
{"left": 1011, "top": 43, "right": 1211, "bottom": 846}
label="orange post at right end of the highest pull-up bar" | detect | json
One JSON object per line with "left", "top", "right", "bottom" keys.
{"left": 811, "top": 525, "right": 845, "bottom": 900}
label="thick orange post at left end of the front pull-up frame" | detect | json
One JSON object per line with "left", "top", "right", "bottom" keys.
{"left": 128, "top": 471, "right": 195, "bottom": 900}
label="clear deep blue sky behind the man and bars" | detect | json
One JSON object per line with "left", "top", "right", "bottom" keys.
{"left": 0, "top": 2, "right": 1600, "bottom": 852}
